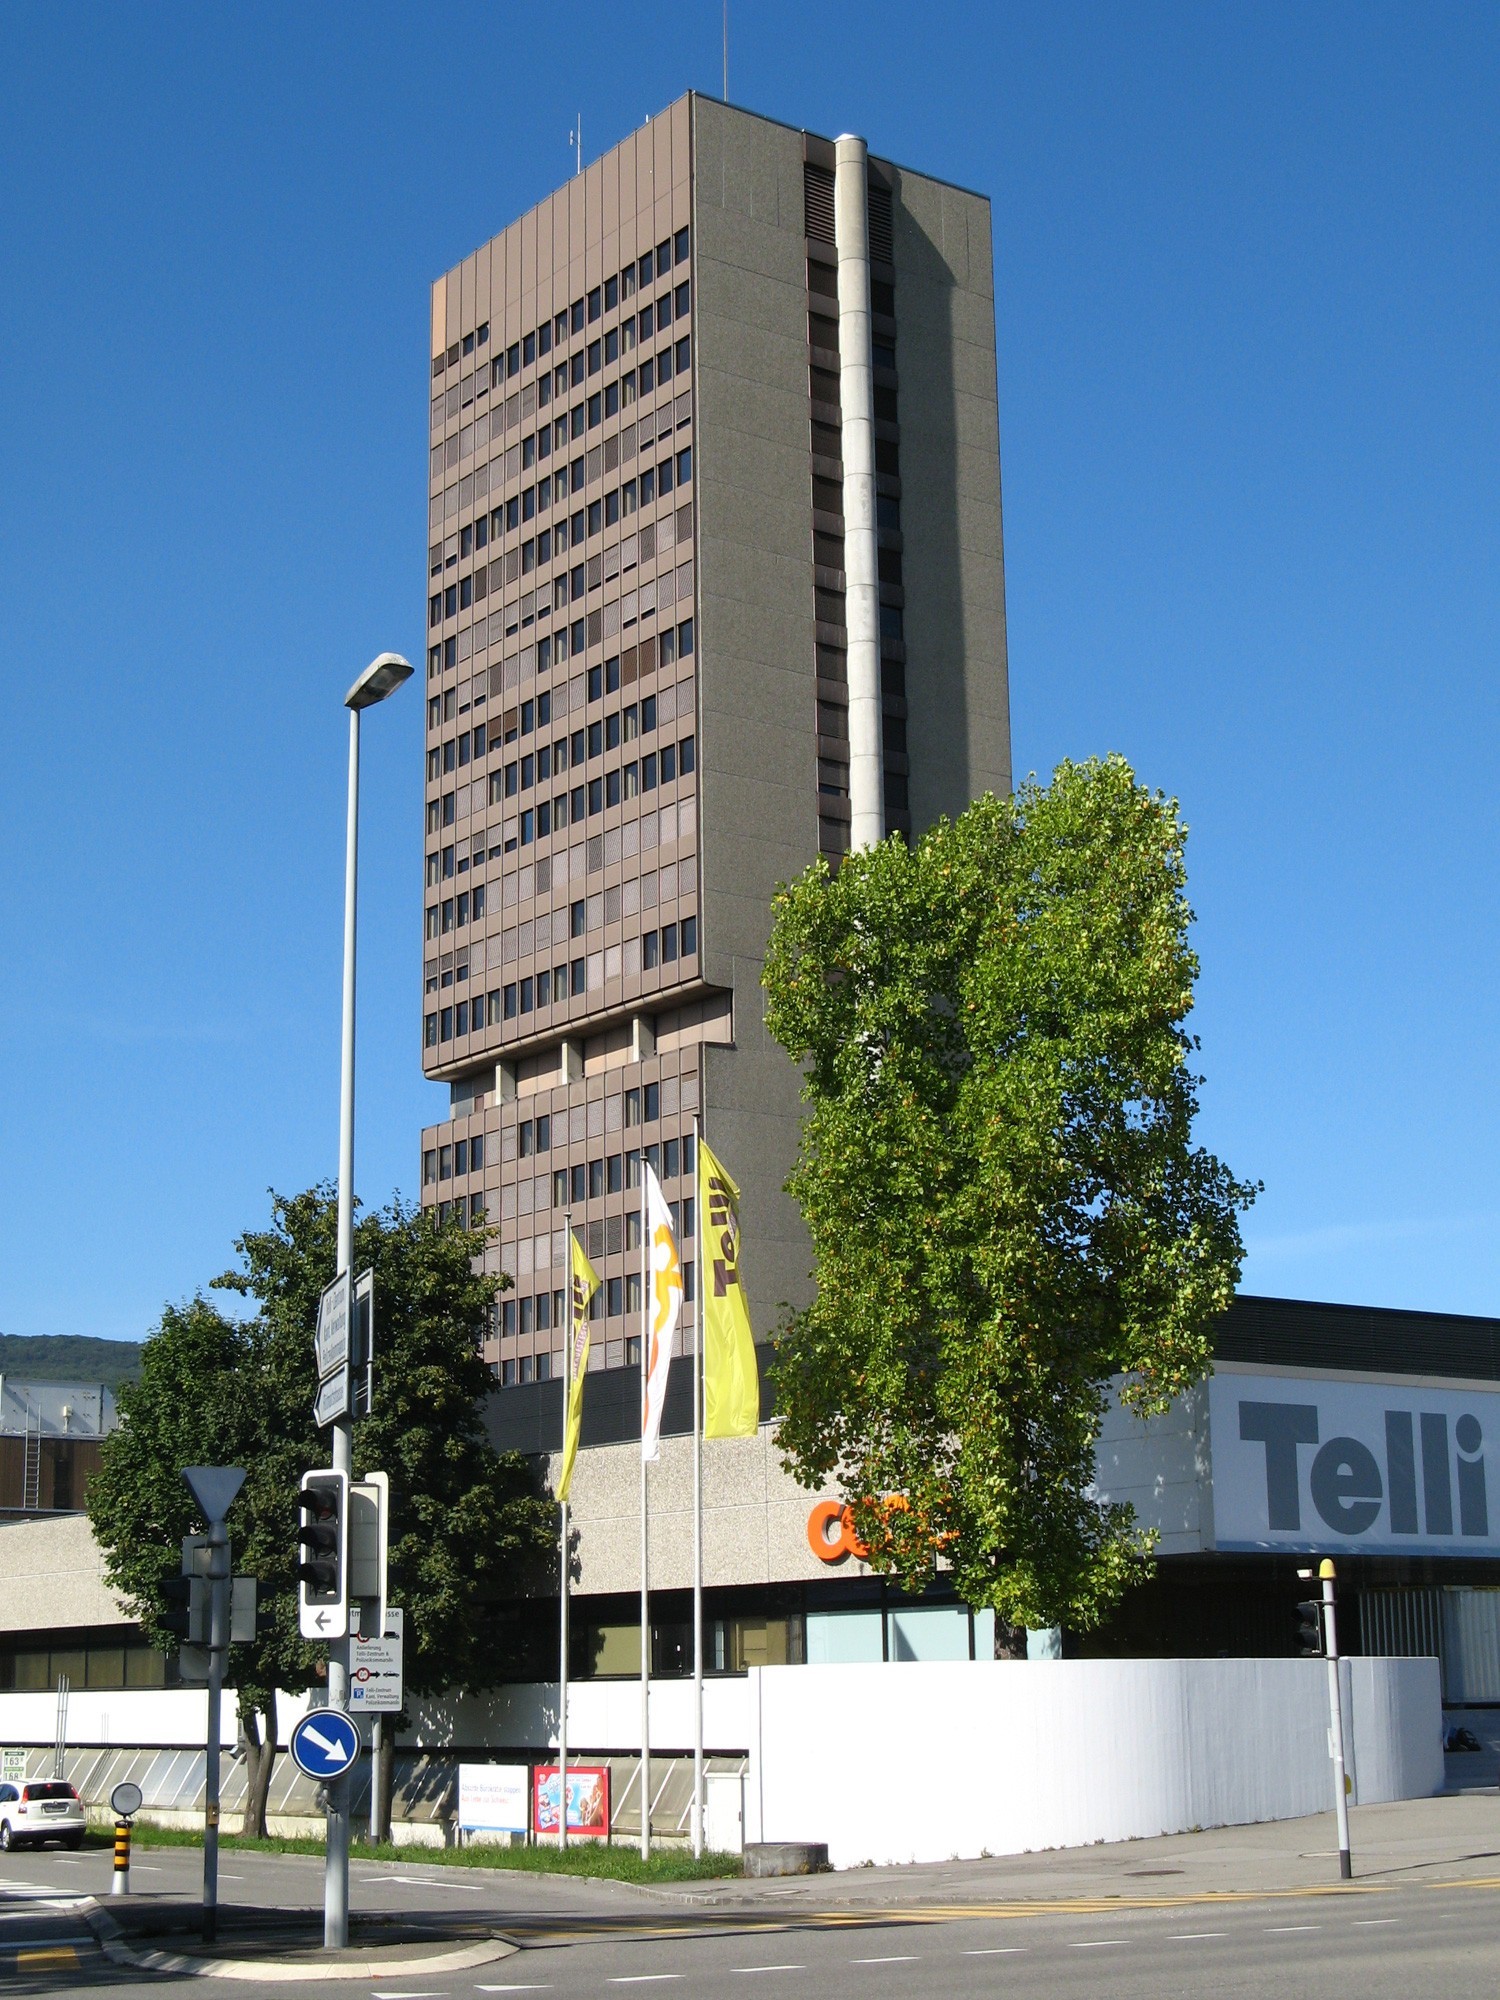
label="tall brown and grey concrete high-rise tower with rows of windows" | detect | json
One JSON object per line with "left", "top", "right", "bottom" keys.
{"left": 422, "top": 96, "right": 1010, "bottom": 1382}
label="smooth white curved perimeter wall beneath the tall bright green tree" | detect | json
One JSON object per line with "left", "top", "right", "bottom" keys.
{"left": 746, "top": 1660, "right": 1442, "bottom": 1868}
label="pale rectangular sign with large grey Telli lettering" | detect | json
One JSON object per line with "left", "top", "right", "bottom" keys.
{"left": 1208, "top": 1374, "right": 1500, "bottom": 1556}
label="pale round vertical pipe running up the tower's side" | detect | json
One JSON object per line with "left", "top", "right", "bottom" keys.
{"left": 834, "top": 134, "right": 886, "bottom": 850}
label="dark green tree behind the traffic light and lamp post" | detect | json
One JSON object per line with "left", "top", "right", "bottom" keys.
{"left": 88, "top": 1188, "right": 556, "bottom": 1830}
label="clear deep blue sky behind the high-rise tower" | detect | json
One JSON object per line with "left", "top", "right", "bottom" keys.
{"left": 0, "top": 11, "right": 1500, "bottom": 1336}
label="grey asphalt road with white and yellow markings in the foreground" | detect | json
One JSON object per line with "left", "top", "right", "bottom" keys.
{"left": 0, "top": 1848, "right": 1500, "bottom": 2000}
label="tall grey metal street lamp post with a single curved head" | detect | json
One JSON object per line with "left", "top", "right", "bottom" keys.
{"left": 322, "top": 652, "right": 412, "bottom": 1952}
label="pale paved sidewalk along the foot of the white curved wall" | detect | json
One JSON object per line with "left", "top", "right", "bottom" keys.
{"left": 680, "top": 1792, "right": 1500, "bottom": 1912}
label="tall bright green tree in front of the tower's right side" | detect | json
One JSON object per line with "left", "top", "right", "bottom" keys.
{"left": 764, "top": 756, "right": 1256, "bottom": 1628}
